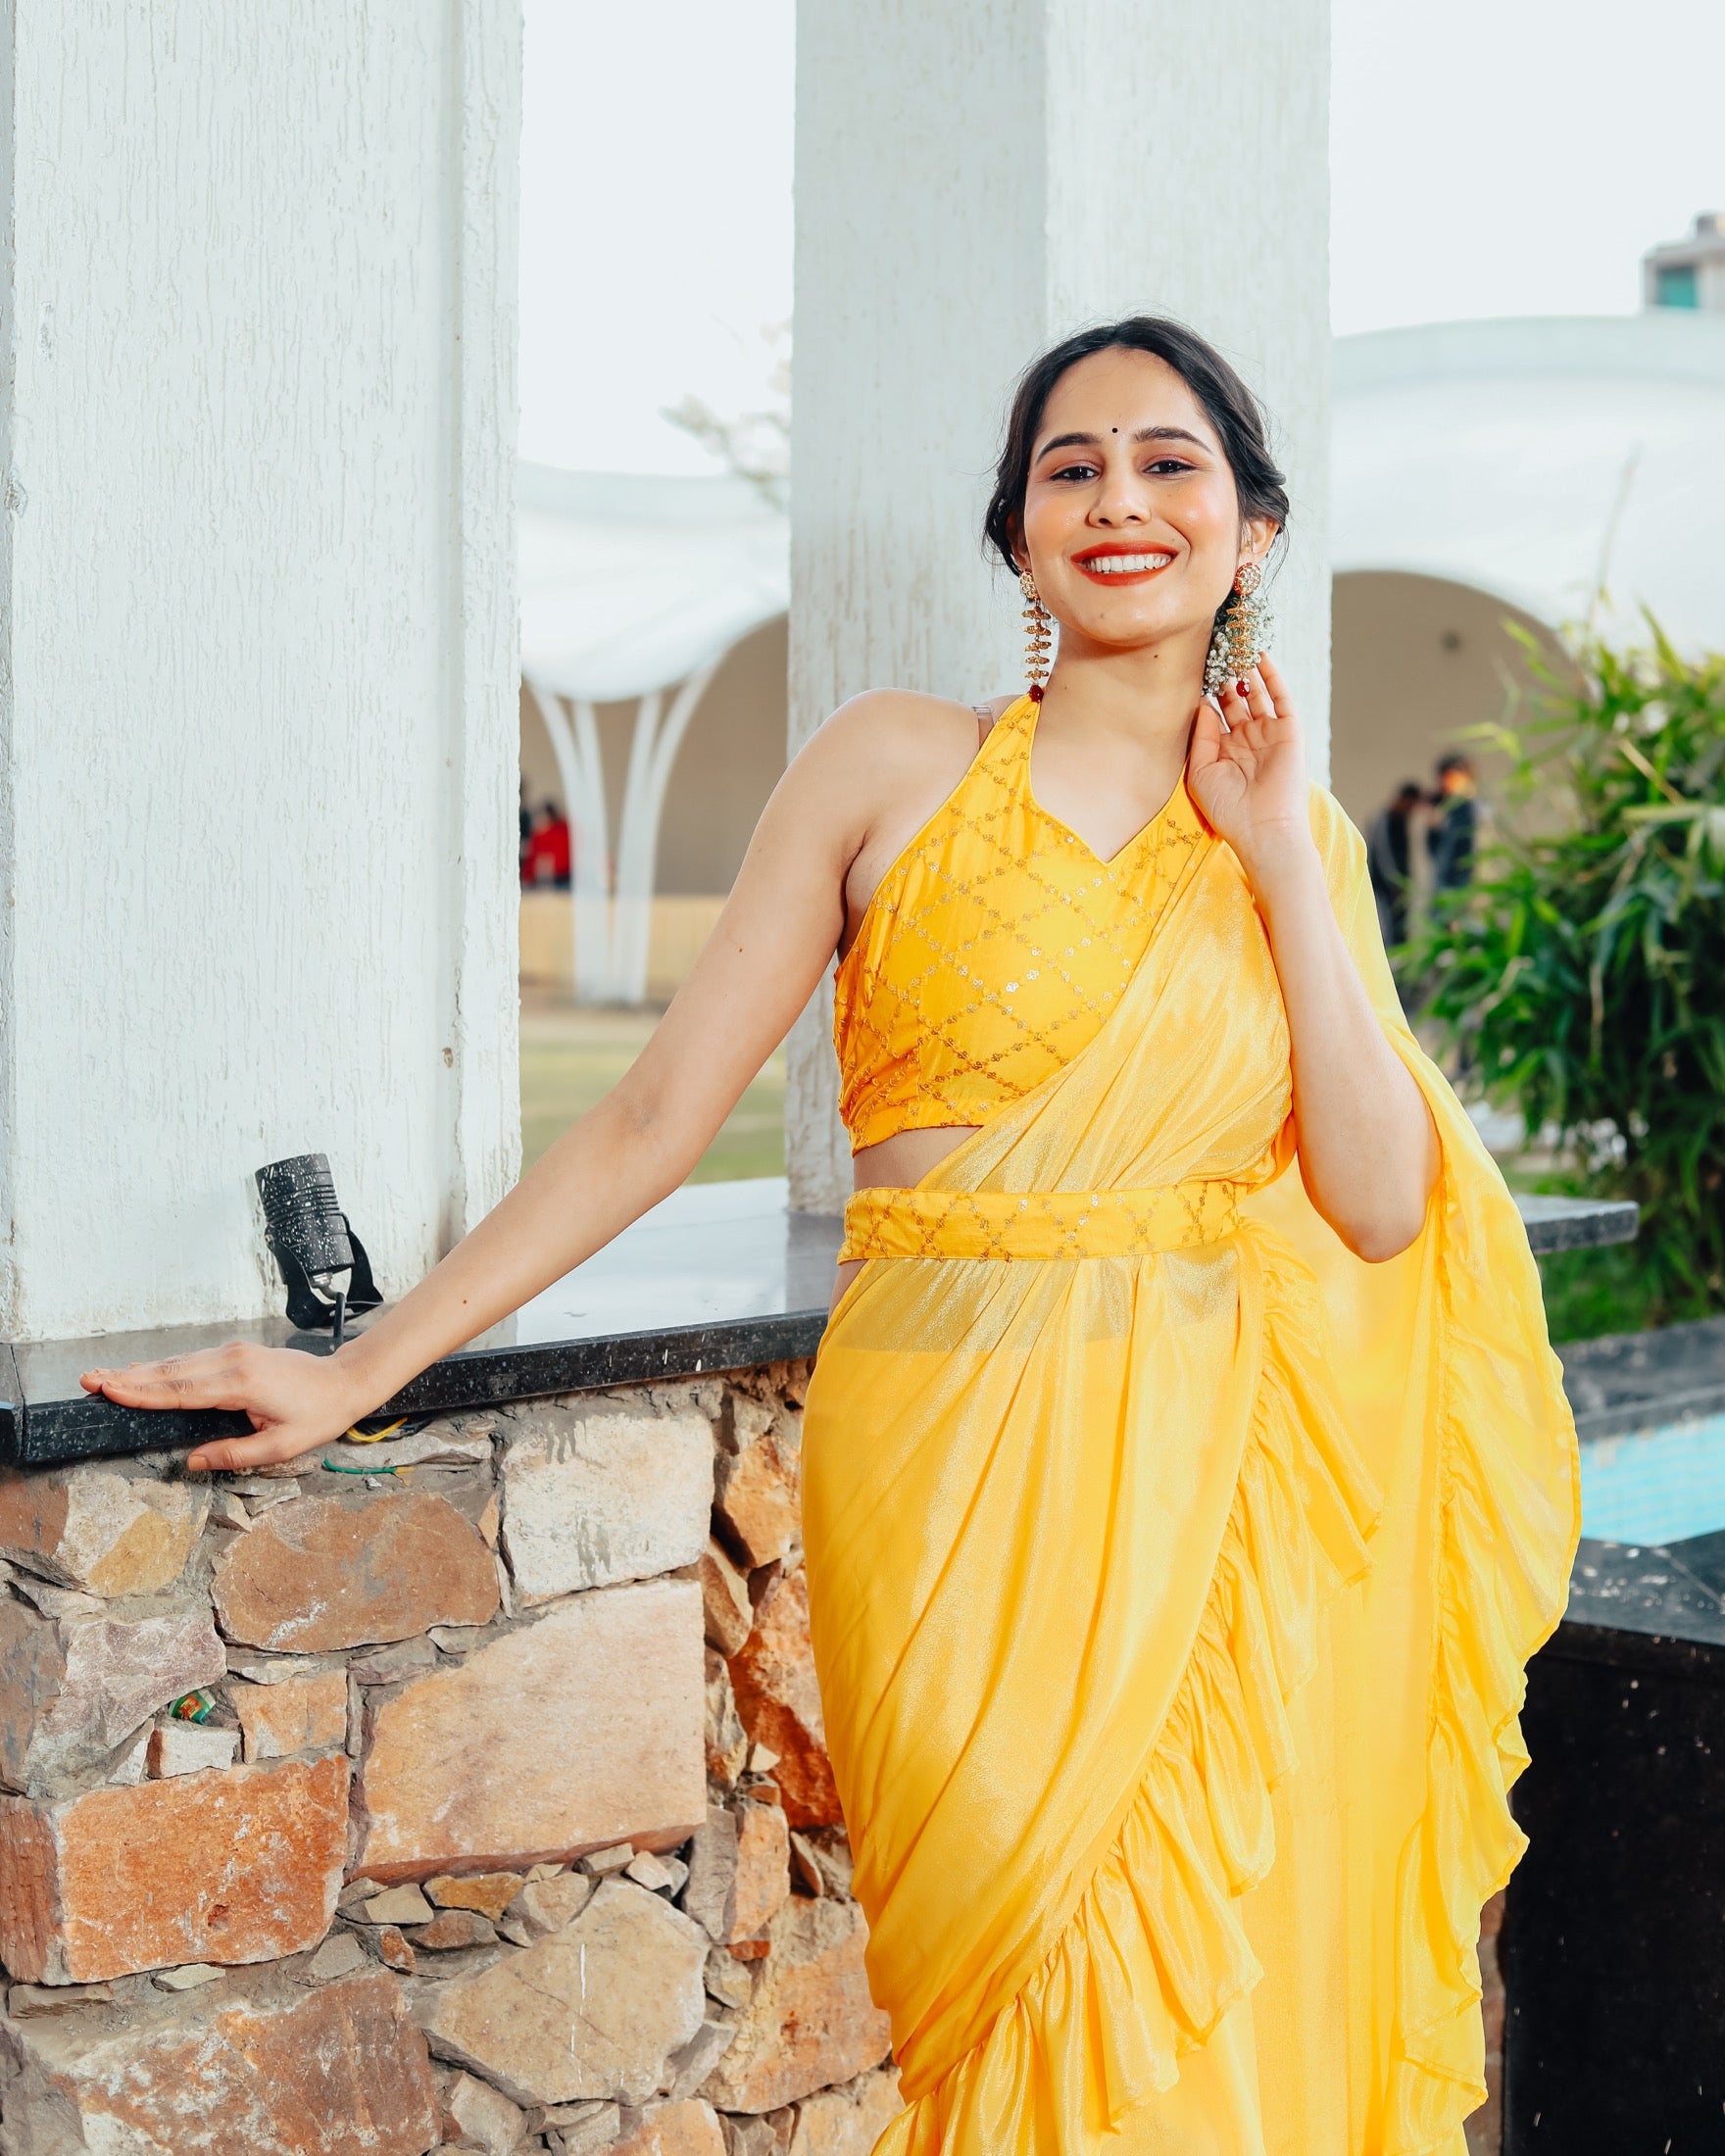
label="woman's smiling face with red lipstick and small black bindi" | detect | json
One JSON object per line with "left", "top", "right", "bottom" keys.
{"left": 1020, "top": 347, "right": 1276, "bottom": 651}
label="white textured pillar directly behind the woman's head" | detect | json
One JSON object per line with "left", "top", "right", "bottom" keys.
{"left": 787, "top": 0, "right": 1330, "bottom": 1211}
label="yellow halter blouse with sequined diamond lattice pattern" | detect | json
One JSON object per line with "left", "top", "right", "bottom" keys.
{"left": 832, "top": 697, "right": 1204, "bottom": 1152}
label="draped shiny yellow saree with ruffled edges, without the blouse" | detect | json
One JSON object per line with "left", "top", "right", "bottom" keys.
{"left": 805, "top": 728, "right": 1578, "bottom": 2156}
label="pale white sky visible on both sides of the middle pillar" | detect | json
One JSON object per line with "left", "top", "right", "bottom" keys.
{"left": 521, "top": 0, "right": 1725, "bottom": 472}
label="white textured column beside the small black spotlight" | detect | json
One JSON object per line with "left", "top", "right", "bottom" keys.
{"left": 0, "top": 0, "right": 519, "bottom": 1339}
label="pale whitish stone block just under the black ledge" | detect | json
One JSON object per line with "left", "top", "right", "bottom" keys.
{"left": 503, "top": 1401, "right": 714, "bottom": 1606}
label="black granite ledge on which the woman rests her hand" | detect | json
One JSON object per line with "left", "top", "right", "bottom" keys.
{"left": 0, "top": 1179, "right": 1635, "bottom": 1466}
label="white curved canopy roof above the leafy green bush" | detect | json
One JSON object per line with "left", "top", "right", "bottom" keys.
{"left": 1330, "top": 309, "right": 1725, "bottom": 651}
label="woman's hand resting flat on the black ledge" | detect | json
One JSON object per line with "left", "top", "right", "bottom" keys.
{"left": 77, "top": 1341, "right": 375, "bottom": 1468}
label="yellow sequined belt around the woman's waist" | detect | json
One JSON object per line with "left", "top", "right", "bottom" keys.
{"left": 839, "top": 1182, "right": 1242, "bottom": 1265}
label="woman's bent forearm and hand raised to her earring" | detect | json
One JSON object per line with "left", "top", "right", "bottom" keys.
{"left": 1188, "top": 660, "right": 1438, "bottom": 1261}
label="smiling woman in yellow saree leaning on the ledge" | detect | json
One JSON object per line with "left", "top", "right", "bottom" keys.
{"left": 84, "top": 319, "right": 1576, "bottom": 2156}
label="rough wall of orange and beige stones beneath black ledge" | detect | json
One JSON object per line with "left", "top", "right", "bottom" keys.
{"left": 0, "top": 1365, "right": 897, "bottom": 2156}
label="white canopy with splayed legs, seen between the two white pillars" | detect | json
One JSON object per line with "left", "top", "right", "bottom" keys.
{"left": 518, "top": 464, "right": 789, "bottom": 1003}
